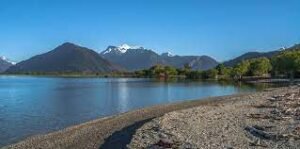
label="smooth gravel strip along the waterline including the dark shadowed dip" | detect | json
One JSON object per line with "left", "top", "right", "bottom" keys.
{"left": 4, "top": 87, "right": 288, "bottom": 149}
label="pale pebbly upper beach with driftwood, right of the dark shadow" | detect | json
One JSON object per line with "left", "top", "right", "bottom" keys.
{"left": 127, "top": 87, "right": 300, "bottom": 149}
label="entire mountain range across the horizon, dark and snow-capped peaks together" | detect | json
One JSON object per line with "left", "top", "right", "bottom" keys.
{"left": 0, "top": 42, "right": 300, "bottom": 73}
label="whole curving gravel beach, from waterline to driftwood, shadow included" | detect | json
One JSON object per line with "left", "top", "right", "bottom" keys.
{"left": 4, "top": 87, "right": 300, "bottom": 149}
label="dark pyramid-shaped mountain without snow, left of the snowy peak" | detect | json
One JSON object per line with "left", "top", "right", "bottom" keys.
{"left": 6, "top": 42, "right": 121, "bottom": 73}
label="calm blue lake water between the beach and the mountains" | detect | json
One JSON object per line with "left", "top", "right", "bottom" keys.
{"left": 0, "top": 76, "right": 270, "bottom": 147}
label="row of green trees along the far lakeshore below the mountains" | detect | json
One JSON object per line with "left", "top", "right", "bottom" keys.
{"left": 135, "top": 50, "right": 300, "bottom": 80}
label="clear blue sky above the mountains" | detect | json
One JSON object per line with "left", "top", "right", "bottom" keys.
{"left": 0, "top": 0, "right": 300, "bottom": 61}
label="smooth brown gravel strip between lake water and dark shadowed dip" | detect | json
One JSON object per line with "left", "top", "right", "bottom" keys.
{"left": 3, "top": 93, "right": 260, "bottom": 148}
